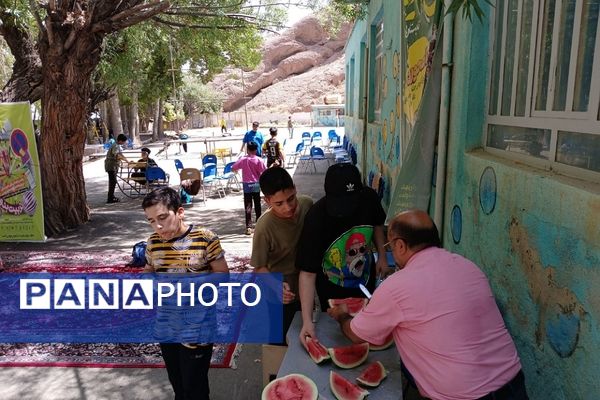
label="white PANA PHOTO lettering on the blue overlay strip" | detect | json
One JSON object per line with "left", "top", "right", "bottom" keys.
{"left": 19, "top": 278, "right": 261, "bottom": 310}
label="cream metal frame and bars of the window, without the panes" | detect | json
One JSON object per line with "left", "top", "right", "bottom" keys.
{"left": 483, "top": 0, "right": 600, "bottom": 181}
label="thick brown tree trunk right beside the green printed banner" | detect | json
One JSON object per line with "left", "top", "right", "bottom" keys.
{"left": 40, "top": 42, "right": 95, "bottom": 236}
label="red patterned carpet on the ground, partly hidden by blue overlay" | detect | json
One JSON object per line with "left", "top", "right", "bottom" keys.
{"left": 0, "top": 252, "right": 249, "bottom": 368}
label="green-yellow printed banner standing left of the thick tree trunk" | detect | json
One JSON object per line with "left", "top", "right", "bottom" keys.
{"left": 0, "top": 102, "right": 46, "bottom": 242}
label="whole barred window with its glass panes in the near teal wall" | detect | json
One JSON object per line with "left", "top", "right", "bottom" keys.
{"left": 485, "top": 0, "right": 600, "bottom": 179}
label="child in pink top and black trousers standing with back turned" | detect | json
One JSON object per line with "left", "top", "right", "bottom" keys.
{"left": 231, "top": 142, "right": 267, "bottom": 235}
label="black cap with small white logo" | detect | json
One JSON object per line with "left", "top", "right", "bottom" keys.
{"left": 325, "top": 163, "right": 363, "bottom": 217}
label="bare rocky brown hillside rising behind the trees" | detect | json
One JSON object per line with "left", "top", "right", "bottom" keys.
{"left": 211, "top": 16, "right": 351, "bottom": 114}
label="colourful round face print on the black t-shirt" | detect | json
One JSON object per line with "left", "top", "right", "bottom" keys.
{"left": 323, "top": 225, "right": 373, "bottom": 288}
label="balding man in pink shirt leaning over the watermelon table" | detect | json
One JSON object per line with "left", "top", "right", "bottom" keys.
{"left": 328, "top": 210, "right": 528, "bottom": 400}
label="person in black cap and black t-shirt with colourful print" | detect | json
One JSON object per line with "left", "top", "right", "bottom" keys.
{"left": 296, "top": 164, "right": 389, "bottom": 347}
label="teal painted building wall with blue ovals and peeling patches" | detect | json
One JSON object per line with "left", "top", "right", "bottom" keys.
{"left": 346, "top": 0, "right": 600, "bottom": 400}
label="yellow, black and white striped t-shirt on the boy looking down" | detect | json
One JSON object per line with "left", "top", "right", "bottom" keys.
{"left": 146, "top": 225, "right": 225, "bottom": 273}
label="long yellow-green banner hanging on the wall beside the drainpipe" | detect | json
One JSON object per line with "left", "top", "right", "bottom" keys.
{"left": 387, "top": 0, "right": 442, "bottom": 219}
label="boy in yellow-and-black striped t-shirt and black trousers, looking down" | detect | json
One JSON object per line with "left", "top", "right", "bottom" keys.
{"left": 142, "top": 188, "right": 229, "bottom": 400}
